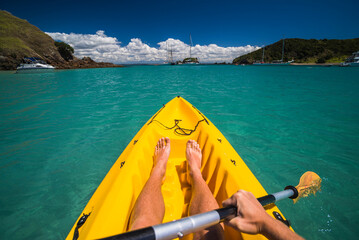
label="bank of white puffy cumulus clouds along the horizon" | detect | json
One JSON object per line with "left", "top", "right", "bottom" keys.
{"left": 47, "top": 30, "right": 260, "bottom": 63}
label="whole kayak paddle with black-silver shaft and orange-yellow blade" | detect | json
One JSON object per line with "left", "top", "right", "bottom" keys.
{"left": 101, "top": 172, "right": 321, "bottom": 240}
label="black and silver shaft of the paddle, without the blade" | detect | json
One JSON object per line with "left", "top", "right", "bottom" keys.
{"left": 101, "top": 186, "right": 298, "bottom": 240}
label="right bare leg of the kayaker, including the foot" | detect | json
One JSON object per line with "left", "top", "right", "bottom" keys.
{"left": 186, "top": 140, "right": 224, "bottom": 239}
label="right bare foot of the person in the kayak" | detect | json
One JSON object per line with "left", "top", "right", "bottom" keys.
{"left": 186, "top": 140, "right": 202, "bottom": 180}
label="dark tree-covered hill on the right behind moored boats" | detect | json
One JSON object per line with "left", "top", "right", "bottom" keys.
{"left": 233, "top": 38, "right": 359, "bottom": 64}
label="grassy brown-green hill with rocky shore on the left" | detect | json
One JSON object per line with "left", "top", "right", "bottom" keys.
{"left": 0, "top": 10, "right": 122, "bottom": 70}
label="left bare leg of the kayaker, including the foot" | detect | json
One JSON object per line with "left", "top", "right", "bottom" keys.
{"left": 130, "top": 138, "right": 170, "bottom": 230}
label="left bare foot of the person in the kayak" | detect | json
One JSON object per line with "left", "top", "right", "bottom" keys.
{"left": 153, "top": 137, "right": 171, "bottom": 176}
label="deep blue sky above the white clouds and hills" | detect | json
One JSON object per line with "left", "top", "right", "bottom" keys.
{"left": 0, "top": 0, "right": 359, "bottom": 62}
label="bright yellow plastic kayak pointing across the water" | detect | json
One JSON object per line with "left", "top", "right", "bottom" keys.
{"left": 66, "top": 97, "right": 292, "bottom": 240}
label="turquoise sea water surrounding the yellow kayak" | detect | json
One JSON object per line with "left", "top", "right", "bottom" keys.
{"left": 0, "top": 66, "right": 359, "bottom": 239}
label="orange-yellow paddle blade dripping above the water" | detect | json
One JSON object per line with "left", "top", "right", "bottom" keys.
{"left": 293, "top": 171, "right": 322, "bottom": 203}
